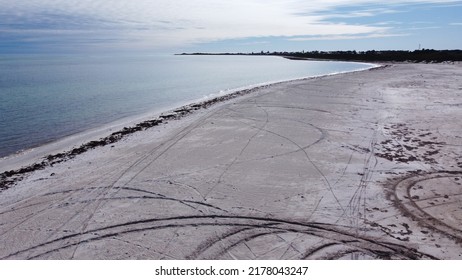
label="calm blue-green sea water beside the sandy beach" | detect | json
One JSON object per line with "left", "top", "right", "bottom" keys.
{"left": 0, "top": 55, "right": 370, "bottom": 157}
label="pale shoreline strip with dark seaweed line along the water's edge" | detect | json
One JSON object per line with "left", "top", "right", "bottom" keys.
{"left": 0, "top": 61, "right": 378, "bottom": 190}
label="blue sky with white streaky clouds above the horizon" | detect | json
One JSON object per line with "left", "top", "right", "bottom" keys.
{"left": 0, "top": 0, "right": 462, "bottom": 53}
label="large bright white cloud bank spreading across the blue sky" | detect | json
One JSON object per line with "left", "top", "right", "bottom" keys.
{"left": 0, "top": 0, "right": 458, "bottom": 48}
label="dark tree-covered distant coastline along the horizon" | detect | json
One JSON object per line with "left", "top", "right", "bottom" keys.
{"left": 177, "top": 49, "right": 462, "bottom": 63}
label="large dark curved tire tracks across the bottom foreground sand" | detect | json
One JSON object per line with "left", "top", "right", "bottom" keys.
{"left": 1, "top": 215, "right": 433, "bottom": 259}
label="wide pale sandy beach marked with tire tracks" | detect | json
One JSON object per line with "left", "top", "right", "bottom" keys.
{"left": 0, "top": 64, "right": 462, "bottom": 259}
